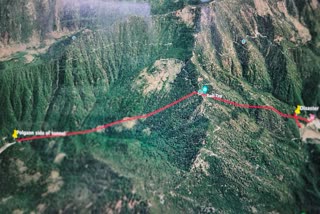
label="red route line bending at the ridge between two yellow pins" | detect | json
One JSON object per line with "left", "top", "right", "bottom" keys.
{"left": 16, "top": 91, "right": 311, "bottom": 142}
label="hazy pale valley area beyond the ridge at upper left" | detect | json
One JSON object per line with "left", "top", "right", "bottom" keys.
{"left": 0, "top": 0, "right": 150, "bottom": 61}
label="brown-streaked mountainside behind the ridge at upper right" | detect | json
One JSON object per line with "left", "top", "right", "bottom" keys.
{"left": 189, "top": 0, "right": 320, "bottom": 105}
